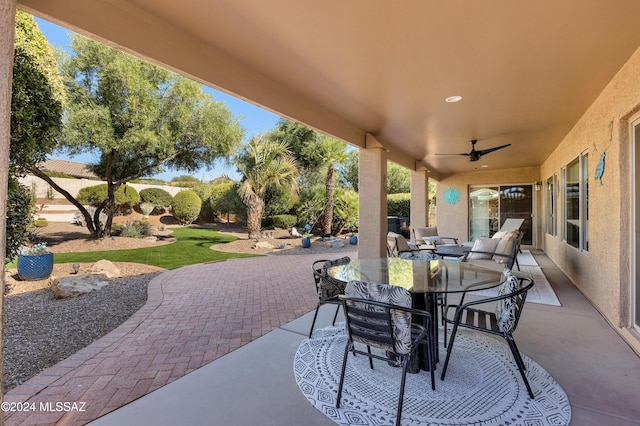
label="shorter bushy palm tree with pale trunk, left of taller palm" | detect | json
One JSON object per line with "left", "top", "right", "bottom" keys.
{"left": 234, "top": 136, "right": 298, "bottom": 238}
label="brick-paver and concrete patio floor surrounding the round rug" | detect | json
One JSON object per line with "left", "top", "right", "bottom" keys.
{"left": 5, "top": 251, "right": 640, "bottom": 426}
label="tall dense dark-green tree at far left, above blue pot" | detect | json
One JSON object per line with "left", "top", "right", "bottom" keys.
{"left": 5, "top": 11, "right": 64, "bottom": 260}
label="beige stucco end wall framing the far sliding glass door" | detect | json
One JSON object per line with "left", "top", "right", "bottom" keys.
{"left": 436, "top": 167, "right": 542, "bottom": 243}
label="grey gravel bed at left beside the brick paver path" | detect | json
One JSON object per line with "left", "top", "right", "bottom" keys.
{"left": 3, "top": 265, "right": 161, "bottom": 393}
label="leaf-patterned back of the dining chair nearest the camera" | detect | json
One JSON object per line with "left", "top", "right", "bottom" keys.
{"left": 341, "top": 281, "right": 412, "bottom": 355}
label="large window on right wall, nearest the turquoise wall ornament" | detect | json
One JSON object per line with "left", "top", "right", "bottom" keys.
{"left": 563, "top": 153, "right": 589, "bottom": 250}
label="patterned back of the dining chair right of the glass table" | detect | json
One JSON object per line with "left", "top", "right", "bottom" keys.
{"left": 496, "top": 268, "right": 533, "bottom": 334}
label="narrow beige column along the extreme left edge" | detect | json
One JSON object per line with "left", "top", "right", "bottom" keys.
{"left": 0, "top": 0, "right": 16, "bottom": 412}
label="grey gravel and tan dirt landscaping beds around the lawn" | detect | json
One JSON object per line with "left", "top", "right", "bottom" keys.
{"left": 3, "top": 222, "right": 357, "bottom": 393}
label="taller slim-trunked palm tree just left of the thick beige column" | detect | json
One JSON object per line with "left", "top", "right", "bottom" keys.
{"left": 271, "top": 119, "right": 346, "bottom": 235}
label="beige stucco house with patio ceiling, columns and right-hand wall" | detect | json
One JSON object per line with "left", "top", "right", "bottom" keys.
{"left": 0, "top": 0, "right": 640, "bottom": 352}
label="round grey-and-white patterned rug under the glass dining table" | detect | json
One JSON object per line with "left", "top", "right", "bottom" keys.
{"left": 293, "top": 324, "right": 571, "bottom": 426}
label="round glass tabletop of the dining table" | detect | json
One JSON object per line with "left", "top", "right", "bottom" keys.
{"left": 327, "top": 257, "right": 503, "bottom": 293}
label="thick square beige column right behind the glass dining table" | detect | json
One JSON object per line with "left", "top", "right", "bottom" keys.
{"left": 358, "top": 135, "right": 387, "bottom": 259}
